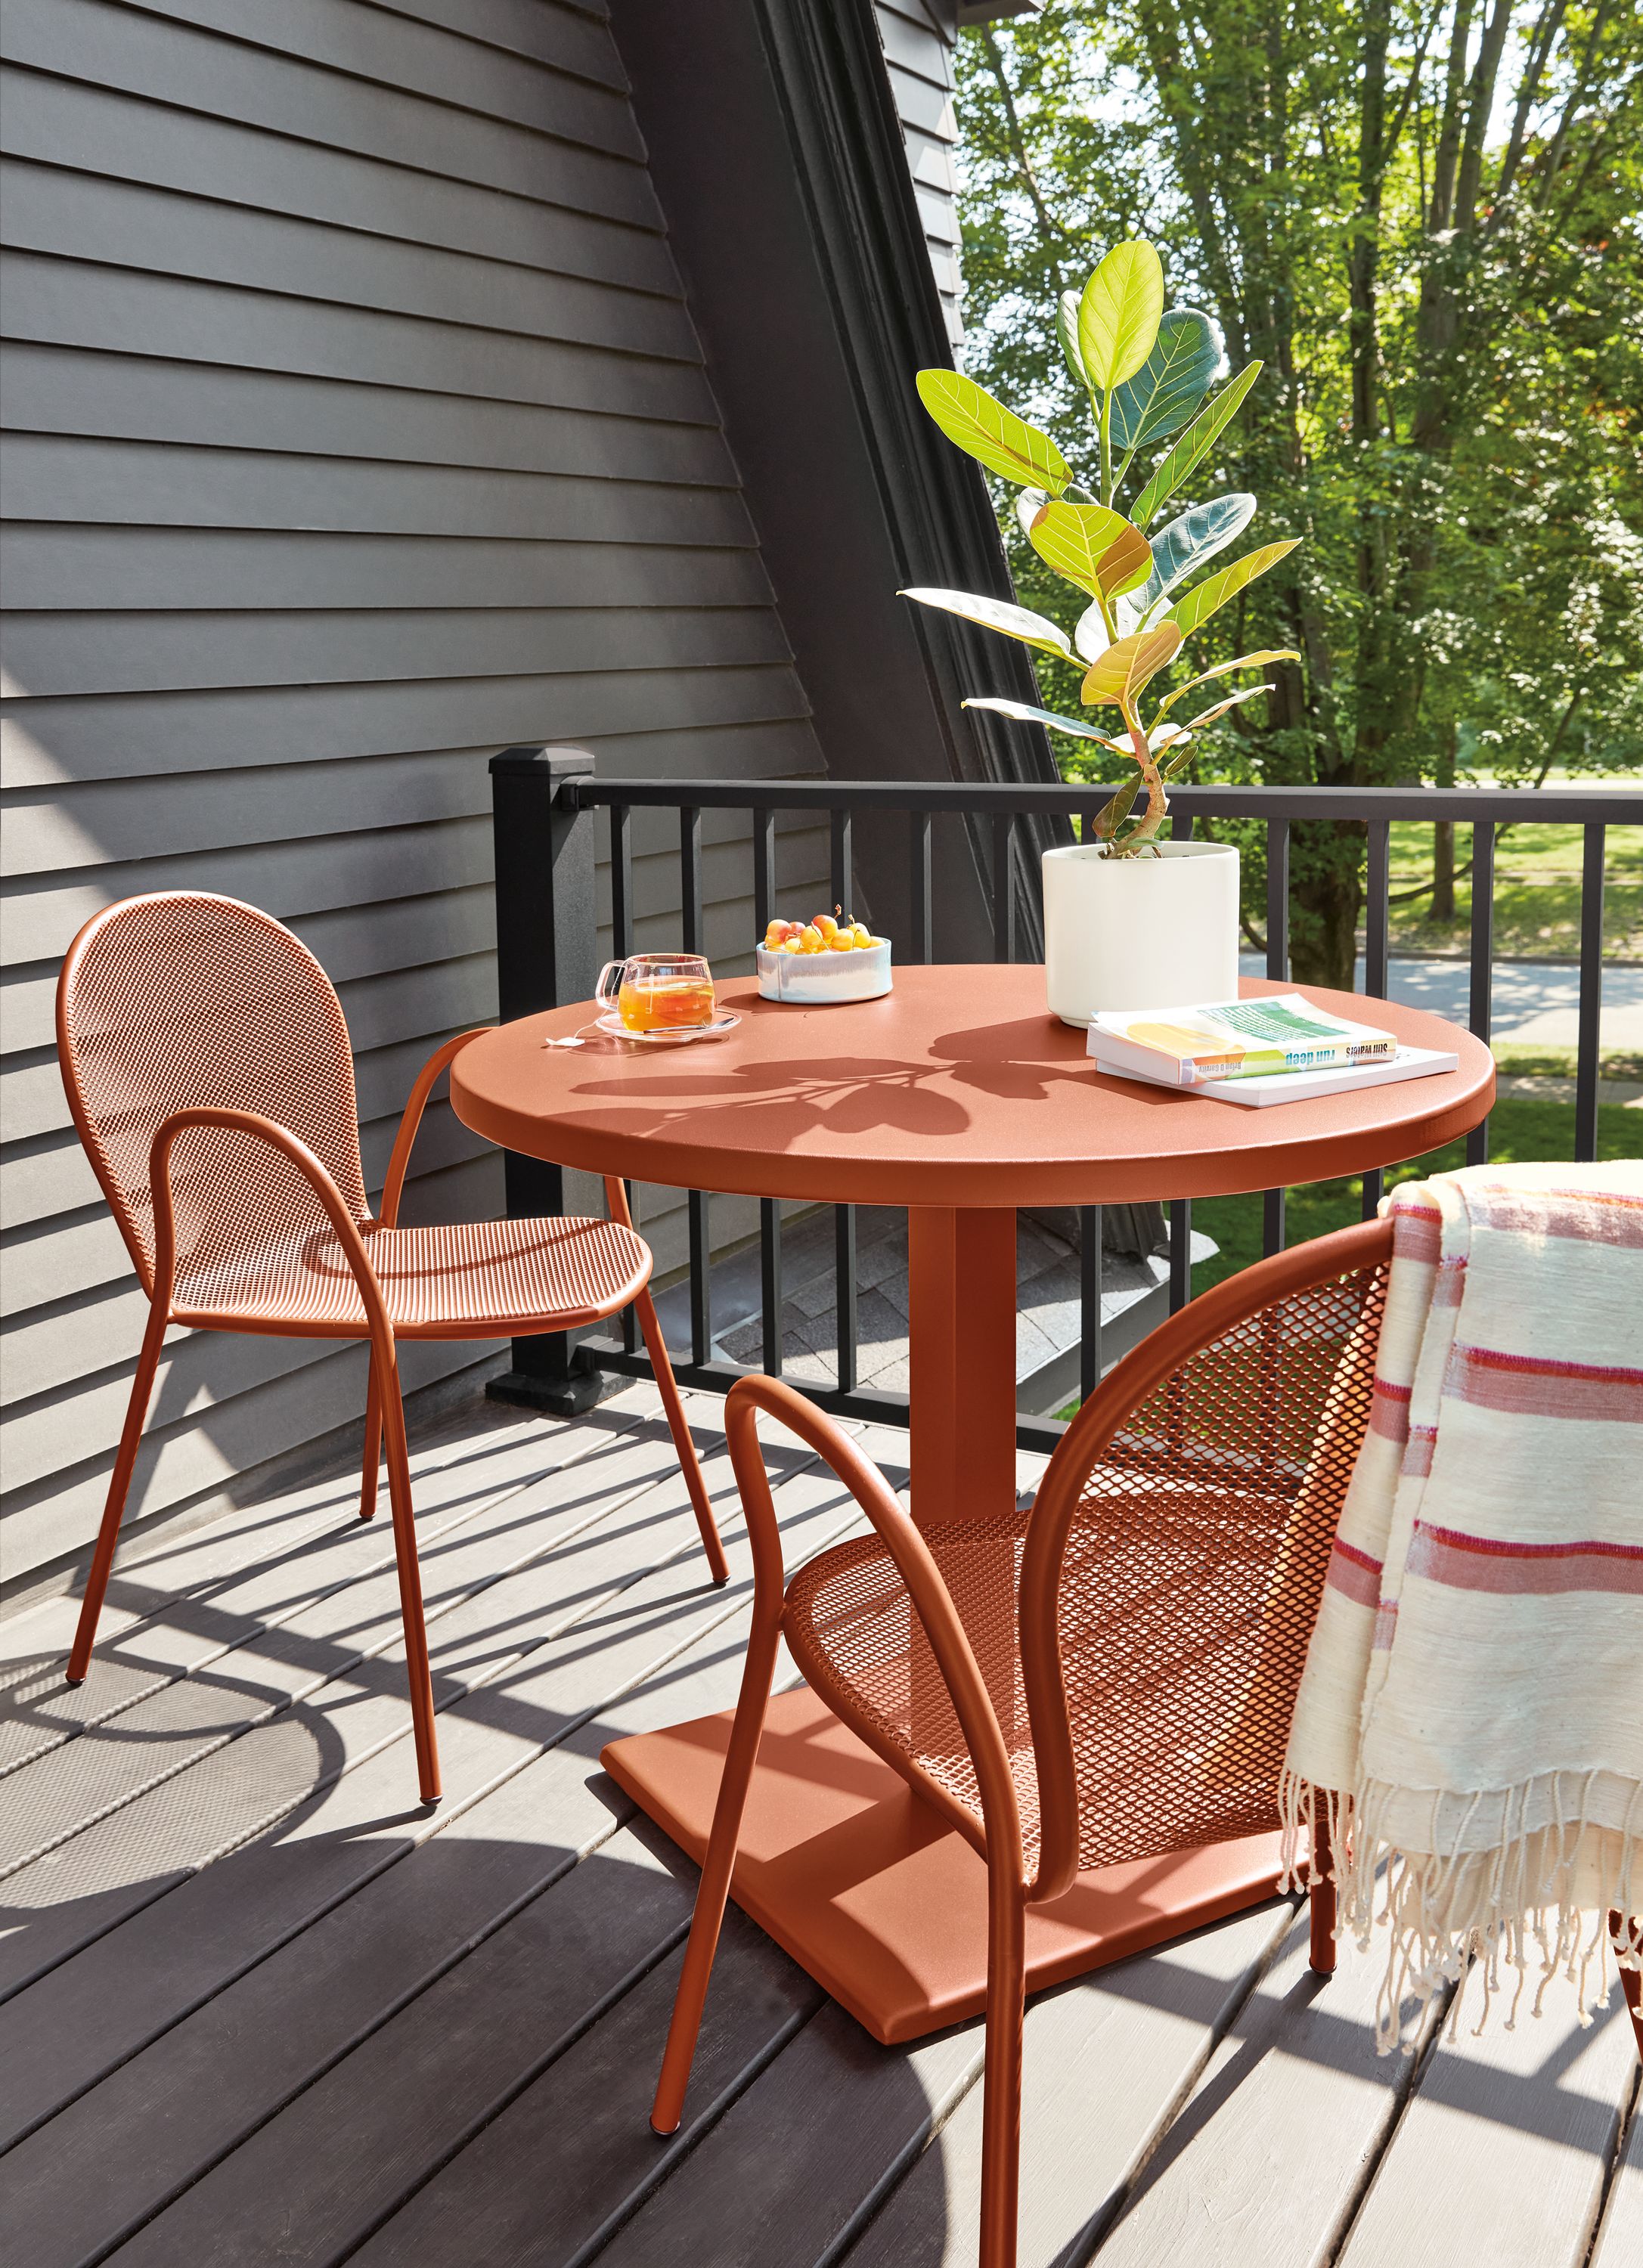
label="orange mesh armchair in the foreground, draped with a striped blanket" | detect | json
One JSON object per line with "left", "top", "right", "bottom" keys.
{"left": 651, "top": 1220, "right": 1391, "bottom": 2268}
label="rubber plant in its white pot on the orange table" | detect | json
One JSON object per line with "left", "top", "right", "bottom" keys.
{"left": 901, "top": 238, "right": 1296, "bottom": 1025}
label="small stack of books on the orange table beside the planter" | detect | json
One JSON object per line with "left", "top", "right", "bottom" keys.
{"left": 1090, "top": 993, "right": 1457, "bottom": 1105}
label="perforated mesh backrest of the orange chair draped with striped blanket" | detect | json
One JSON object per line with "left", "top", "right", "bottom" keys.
{"left": 1058, "top": 1266, "right": 1384, "bottom": 1867}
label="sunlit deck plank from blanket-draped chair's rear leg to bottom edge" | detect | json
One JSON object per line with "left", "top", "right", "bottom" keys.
{"left": 1096, "top": 1910, "right": 1412, "bottom": 2268}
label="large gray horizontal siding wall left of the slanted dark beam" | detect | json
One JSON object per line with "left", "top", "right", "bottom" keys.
{"left": 0, "top": 0, "right": 826, "bottom": 1581}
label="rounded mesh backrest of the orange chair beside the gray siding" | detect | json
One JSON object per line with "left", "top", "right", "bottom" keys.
{"left": 59, "top": 891, "right": 370, "bottom": 1304}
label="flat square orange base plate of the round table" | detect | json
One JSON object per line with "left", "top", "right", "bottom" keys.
{"left": 599, "top": 1685, "right": 1278, "bottom": 2046}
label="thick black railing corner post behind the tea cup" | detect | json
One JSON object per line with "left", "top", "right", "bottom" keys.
{"left": 485, "top": 748, "right": 601, "bottom": 1418}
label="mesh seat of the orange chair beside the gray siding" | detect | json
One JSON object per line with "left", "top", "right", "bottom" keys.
{"left": 175, "top": 1218, "right": 651, "bottom": 1338}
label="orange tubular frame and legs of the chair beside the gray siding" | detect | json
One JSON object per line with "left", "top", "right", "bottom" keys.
{"left": 57, "top": 891, "right": 730, "bottom": 1803}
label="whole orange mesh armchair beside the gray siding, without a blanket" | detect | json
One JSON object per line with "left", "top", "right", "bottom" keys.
{"left": 57, "top": 891, "right": 728, "bottom": 1803}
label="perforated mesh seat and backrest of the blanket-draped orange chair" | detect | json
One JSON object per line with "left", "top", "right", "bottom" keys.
{"left": 785, "top": 1270, "right": 1384, "bottom": 1867}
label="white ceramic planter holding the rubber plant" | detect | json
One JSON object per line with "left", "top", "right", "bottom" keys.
{"left": 1044, "top": 844, "right": 1239, "bottom": 1025}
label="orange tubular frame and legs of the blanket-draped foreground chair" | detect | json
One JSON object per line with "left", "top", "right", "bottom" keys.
{"left": 651, "top": 1220, "right": 1391, "bottom": 2268}
